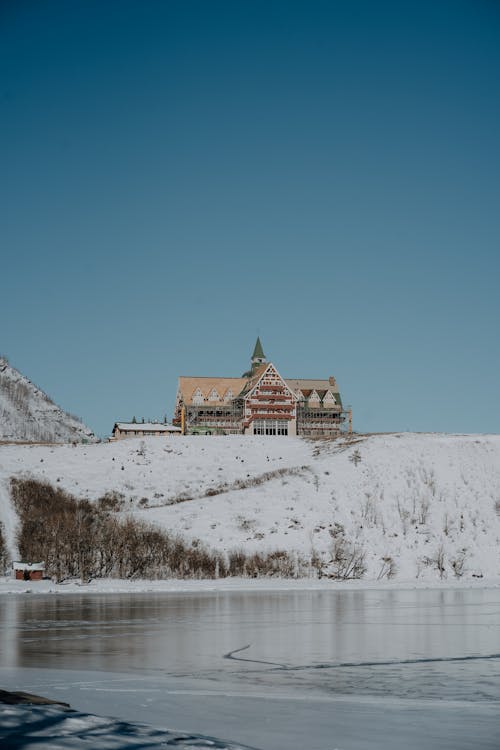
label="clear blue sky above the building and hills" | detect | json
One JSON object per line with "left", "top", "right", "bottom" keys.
{"left": 0, "top": 0, "right": 500, "bottom": 435}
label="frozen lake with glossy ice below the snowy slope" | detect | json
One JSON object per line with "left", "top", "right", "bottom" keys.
{"left": 0, "top": 588, "right": 500, "bottom": 750}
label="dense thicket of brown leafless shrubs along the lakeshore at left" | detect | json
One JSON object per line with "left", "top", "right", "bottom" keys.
{"left": 8, "top": 479, "right": 307, "bottom": 581}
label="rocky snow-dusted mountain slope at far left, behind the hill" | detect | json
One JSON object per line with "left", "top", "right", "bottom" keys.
{"left": 0, "top": 357, "right": 95, "bottom": 443}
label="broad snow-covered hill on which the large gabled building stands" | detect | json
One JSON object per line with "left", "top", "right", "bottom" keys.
{"left": 0, "top": 433, "right": 500, "bottom": 581}
